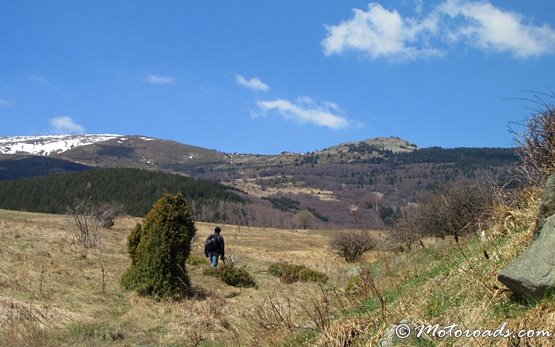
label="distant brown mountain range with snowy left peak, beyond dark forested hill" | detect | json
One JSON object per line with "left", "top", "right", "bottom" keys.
{"left": 0, "top": 134, "right": 518, "bottom": 228}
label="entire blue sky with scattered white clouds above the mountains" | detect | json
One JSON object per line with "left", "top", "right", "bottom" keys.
{"left": 0, "top": 0, "right": 555, "bottom": 154}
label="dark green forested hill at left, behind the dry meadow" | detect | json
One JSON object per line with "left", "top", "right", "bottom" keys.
{"left": 0, "top": 169, "right": 245, "bottom": 219}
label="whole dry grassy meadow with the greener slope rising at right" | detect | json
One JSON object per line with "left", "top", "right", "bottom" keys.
{"left": 0, "top": 191, "right": 555, "bottom": 347}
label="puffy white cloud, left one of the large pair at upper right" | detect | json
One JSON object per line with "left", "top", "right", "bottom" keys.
{"left": 322, "top": 3, "right": 441, "bottom": 59}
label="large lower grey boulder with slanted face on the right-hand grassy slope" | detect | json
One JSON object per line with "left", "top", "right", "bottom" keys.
{"left": 497, "top": 215, "right": 555, "bottom": 300}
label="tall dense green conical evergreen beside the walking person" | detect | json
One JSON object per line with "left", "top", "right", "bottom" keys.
{"left": 122, "top": 193, "right": 196, "bottom": 299}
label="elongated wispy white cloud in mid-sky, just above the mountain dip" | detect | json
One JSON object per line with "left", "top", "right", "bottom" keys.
{"left": 253, "top": 97, "right": 350, "bottom": 129}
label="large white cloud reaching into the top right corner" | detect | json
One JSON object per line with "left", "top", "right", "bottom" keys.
{"left": 438, "top": 0, "right": 555, "bottom": 58}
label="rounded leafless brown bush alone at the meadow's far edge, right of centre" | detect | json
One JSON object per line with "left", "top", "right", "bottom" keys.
{"left": 330, "top": 230, "right": 376, "bottom": 262}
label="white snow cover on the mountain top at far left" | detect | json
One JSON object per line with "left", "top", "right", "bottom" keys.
{"left": 0, "top": 134, "right": 124, "bottom": 155}
